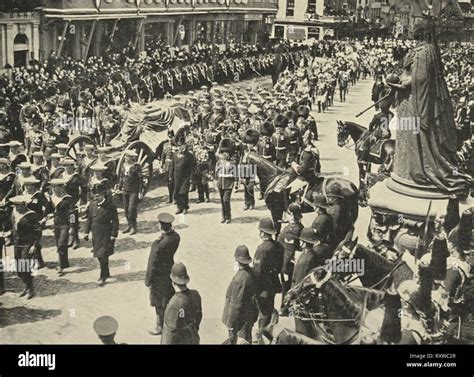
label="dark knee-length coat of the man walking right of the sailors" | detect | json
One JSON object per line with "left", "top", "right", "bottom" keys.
{"left": 84, "top": 198, "right": 119, "bottom": 258}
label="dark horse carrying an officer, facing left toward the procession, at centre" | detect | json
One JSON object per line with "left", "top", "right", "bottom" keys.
{"left": 242, "top": 152, "right": 359, "bottom": 239}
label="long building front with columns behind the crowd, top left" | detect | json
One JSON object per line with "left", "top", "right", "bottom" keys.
{"left": 41, "top": 0, "right": 278, "bottom": 59}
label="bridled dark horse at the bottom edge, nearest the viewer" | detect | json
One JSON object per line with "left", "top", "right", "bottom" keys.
{"left": 277, "top": 267, "right": 431, "bottom": 344}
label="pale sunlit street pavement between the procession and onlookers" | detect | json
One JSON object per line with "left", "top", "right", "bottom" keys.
{"left": 0, "top": 79, "right": 374, "bottom": 344}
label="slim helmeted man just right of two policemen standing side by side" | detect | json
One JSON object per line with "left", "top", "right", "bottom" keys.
{"left": 278, "top": 203, "right": 303, "bottom": 317}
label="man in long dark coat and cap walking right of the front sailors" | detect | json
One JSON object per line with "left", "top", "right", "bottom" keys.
{"left": 84, "top": 184, "right": 119, "bottom": 287}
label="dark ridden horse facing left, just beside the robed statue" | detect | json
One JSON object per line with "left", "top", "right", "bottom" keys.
{"left": 337, "top": 120, "right": 395, "bottom": 181}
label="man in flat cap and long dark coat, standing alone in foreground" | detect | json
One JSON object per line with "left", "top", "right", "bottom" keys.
{"left": 145, "top": 213, "right": 180, "bottom": 335}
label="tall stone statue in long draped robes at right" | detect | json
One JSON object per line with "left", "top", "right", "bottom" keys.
{"left": 387, "top": 18, "right": 471, "bottom": 199}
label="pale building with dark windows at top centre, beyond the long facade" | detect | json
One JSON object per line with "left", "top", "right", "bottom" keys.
{"left": 273, "top": 0, "right": 349, "bottom": 41}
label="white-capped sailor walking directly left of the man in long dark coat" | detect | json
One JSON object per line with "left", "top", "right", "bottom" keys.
{"left": 49, "top": 178, "right": 74, "bottom": 276}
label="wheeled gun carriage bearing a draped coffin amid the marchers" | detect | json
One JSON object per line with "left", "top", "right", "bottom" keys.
{"left": 66, "top": 101, "right": 191, "bottom": 196}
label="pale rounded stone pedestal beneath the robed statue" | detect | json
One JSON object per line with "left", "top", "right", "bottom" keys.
{"left": 368, "top": 174, "right": 474, "bottom": 221}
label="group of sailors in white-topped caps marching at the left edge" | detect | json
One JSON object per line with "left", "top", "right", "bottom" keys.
{"left": 0, "top": 137, "right": 143, "bottom": 298}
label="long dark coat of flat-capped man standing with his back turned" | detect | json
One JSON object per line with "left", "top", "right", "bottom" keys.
{"left": 145, "top": 230, "right": 180, "bottom": 306}
